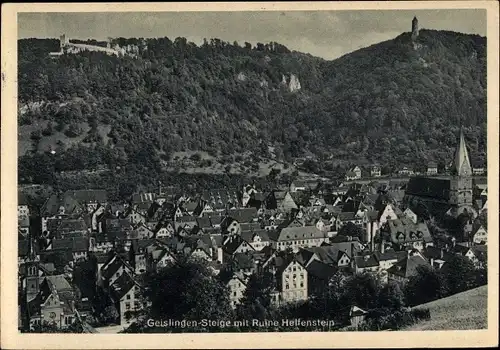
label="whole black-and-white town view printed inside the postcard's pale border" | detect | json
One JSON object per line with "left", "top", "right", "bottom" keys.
{"left": 2, "top": 4, "right": 498, "bottom": 346}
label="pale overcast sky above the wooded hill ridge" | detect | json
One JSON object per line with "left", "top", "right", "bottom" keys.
{"left": 18, "top": 9, "right": 486, "bottom": 59}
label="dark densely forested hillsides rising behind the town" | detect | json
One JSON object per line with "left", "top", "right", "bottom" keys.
{"left": 18, "top": 30, "right": 486, "bottom": 185}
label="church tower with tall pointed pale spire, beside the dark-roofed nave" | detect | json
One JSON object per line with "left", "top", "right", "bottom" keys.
{"left": 450, "top": 129, "right": 475, "bottom": 216}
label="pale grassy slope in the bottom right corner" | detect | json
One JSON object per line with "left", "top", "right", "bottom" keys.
{"left": 403, "top": 286, "right": 488, "bottom": 331}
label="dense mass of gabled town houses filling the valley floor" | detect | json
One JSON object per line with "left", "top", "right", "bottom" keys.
{"left": 18, "top": 167, "right": 487, "bottom": 327}
